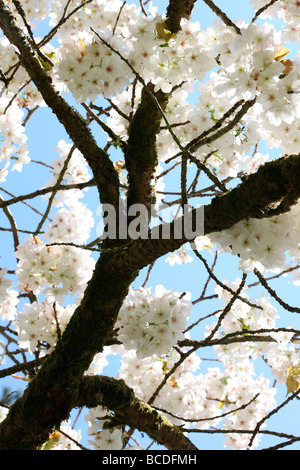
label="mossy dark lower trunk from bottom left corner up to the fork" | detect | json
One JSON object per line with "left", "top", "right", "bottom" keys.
{"left": 0, "top": 248, "right": 137, "bottom": 450}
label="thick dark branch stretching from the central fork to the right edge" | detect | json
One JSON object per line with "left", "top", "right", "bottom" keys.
{"left": 109, "top": 155, "right": 300, "bottom": 270}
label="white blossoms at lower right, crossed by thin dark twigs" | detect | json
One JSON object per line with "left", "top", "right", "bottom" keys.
{"left": 207, "top": 279, "right": 300, "bottom": 448}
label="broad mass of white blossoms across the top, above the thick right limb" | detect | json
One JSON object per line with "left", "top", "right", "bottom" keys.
{"left": 45, "top": 0, "right": 299, "bottom": 195}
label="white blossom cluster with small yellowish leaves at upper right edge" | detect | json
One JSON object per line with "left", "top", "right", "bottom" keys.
{"left": 205, "top": 19, "right": 299, "bottom": 162}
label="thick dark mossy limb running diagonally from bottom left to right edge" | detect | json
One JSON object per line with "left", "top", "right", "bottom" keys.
{"left": 0, "top": 151, "right": 300, "bottom": 450}
